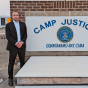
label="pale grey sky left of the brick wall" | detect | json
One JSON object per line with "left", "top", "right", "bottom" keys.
{"left": 0, "top": 0, "right": 10, "bottom": 16}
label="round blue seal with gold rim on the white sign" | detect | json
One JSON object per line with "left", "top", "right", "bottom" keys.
{"left": 57, "top": 26, "right": 73, "bottom": 43}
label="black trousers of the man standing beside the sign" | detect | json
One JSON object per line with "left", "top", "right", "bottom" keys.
{"left": 8, "top": 49, "right": 25, "bottom": 79}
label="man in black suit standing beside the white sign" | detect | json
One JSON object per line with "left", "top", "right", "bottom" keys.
{"left": 5, "top": 12, "right": 27, "bottom": 86}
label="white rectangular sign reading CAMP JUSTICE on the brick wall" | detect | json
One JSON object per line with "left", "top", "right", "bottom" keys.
{"left": 26, "top": 16, "right": 88, "bottom": 51}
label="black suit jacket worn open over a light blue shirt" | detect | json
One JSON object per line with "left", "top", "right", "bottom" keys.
{"left": 5, "top": 21, "right": 27, "bottom": 51}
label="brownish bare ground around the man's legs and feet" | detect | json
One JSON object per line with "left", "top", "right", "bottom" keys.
{"left": 0, "top": 29, "right": 20, "bottom": 88}
